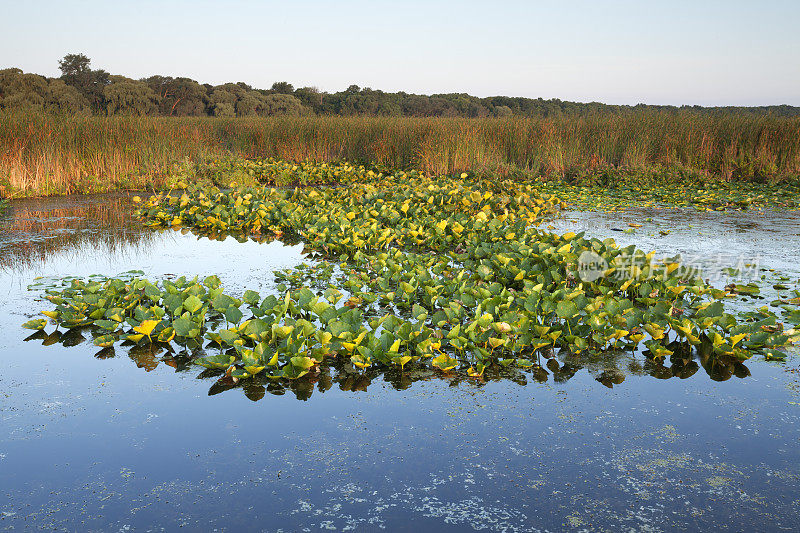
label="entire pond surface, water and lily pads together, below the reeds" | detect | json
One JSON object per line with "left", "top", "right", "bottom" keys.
{"left": 0, "top": 161, "right": 800, "bottom": 531}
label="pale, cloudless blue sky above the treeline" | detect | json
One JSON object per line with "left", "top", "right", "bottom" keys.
{"left": 0, "top": 0, "right": 800, "bottom": 105}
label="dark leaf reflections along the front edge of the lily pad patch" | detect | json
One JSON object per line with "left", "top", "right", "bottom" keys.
{"left": 25, "top": 327, "right": 750, "bottom": 401}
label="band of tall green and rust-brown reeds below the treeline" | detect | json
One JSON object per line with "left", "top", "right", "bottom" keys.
{"left": 0, "top": 111, "right": 800, "bottom": 197}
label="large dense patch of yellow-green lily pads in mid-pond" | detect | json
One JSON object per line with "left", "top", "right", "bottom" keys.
{"left": 21, "top": 164, "right": 800, "bottom": 379}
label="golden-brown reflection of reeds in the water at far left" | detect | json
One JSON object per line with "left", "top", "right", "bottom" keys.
{"left": 0, "top": 195, "right": 155, "bottom": 269}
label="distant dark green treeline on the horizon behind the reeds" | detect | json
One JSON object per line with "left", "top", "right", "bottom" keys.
{"left": 0, "top": 54, "right": 800, "bottom": 118}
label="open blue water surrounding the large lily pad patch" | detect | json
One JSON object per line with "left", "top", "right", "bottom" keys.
{"left": 0, "top": 195, "right": 800, "bottom": 531}
